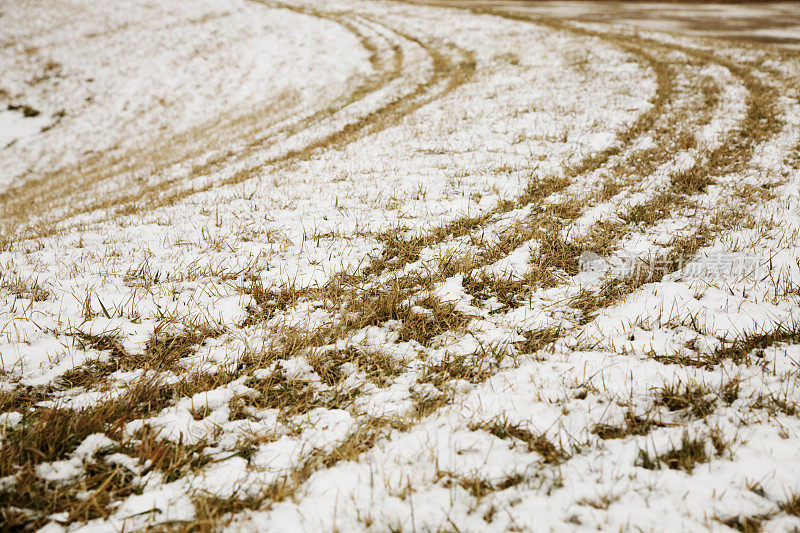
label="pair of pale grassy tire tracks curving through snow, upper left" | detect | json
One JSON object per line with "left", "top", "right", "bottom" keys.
{"left": 0, "top": 2, "right": 475, "bottom": 241}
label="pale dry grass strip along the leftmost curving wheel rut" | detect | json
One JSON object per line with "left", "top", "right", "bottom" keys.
{"left": 0, "top": 5, "right": 402, "bottom": 235}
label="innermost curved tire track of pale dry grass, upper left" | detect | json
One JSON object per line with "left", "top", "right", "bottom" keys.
{"left": 0, "top": 0, "right": 403, "bottom": 237}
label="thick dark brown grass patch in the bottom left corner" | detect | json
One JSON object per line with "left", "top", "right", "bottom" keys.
{"left": 0, "top": 381, "right": 202, "bottom": 527}
